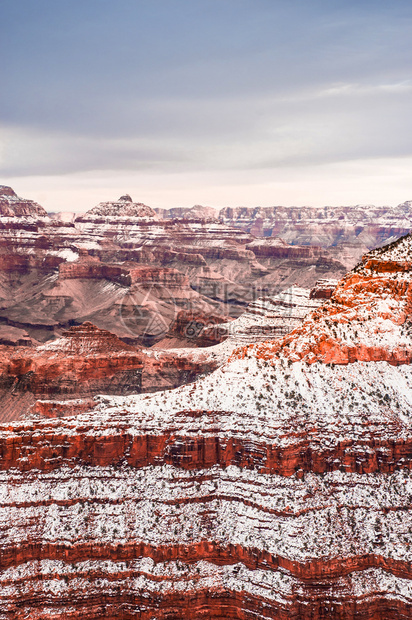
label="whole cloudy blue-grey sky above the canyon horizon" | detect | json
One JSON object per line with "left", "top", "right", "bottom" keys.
{"left": 0, "top": 0, "right": 412, "bottom": 212}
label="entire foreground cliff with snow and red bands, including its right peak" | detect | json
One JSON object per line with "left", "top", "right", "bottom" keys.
{"left": 0, "top": 237, "right": 412, "bottom": 620}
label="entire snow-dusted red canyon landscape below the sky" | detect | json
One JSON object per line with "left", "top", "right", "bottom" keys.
{"left": 0, "top": 186, "right": 412, "bottom": 620}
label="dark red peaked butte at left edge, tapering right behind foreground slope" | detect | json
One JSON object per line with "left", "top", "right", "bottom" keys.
{"left": 0, "top": 322, "right": 222, "bottom": 423}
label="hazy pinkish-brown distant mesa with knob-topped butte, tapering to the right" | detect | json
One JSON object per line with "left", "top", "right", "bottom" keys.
{"left": 0, "top": 188, "right": 346, "bottom": 346}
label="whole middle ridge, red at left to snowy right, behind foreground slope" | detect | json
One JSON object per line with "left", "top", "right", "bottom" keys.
{"left": 0, "top": 282, "right": 331, "bottom": 423}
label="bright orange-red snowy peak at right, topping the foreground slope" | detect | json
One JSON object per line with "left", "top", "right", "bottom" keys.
{"left": 243, "top": 237, "right": 412, "bottom": 365}
